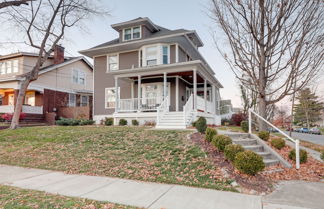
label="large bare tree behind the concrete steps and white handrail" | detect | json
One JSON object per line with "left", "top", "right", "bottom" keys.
{"left": 210, "top": 0, "right": 324, "bottom": 130}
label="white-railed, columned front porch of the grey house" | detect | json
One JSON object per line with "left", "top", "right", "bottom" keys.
{"left": 107, "top": 69, "right": 220, "bottom": 128}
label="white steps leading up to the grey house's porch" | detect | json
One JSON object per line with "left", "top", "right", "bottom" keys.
{"left": 155, "top": 112, "right": 186, "bottom": 129}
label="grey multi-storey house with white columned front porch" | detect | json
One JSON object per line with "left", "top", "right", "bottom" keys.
{"left": 80, "top": 18, "right": 222, "bottom": 128}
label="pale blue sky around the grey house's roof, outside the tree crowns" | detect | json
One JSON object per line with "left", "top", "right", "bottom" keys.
{"left": 0, "top": 0, "right": 324, "bottom": 106}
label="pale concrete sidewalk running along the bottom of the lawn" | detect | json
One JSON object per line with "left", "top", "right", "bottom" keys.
{"left": 0, "top": 165, "right": 323, "bottom": 209}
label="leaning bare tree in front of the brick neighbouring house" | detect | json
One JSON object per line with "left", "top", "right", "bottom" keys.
{"left": 6, "top": 0, "right": 106, "bottom": 129}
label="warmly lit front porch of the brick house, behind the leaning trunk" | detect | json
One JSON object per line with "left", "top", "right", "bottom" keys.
{"left": 0, "top": 89, "right": 43, "bottom": 114}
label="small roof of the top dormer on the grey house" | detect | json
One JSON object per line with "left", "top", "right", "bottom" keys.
{"left": 111, "top": 17, "right": 159, "bottom": 32}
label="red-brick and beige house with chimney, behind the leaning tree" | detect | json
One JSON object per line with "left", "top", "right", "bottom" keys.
{"left": 0, "top": 46, "right": 93, "bottom": 121}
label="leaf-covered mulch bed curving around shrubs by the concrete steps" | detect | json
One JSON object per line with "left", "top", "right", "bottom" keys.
{"left": 190, "top": 132, "right": 324, "bottom": 194}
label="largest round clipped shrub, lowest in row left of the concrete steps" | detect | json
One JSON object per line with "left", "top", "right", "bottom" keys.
{"left": 234, "top": 150, "right": 265, "bottom": 175}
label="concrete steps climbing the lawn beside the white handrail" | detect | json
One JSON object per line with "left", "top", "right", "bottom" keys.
{"left": 226, "top": 134, "right": 280, "bottom": 166}
